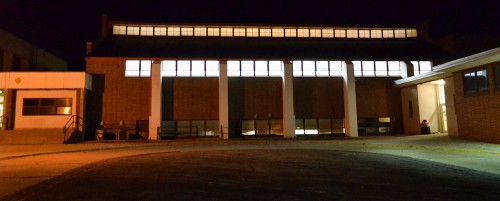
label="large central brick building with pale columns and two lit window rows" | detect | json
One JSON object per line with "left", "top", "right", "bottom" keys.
{"left": 86, "top": 18, "right": 452, "bottom": 139}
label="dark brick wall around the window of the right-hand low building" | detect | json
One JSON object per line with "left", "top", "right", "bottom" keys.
{"left": 454, "top": 66, "right": 500, "bottom": 143}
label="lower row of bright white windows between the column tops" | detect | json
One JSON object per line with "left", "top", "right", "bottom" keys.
{"left": 125, "top": 60, "right": 431, "bottom": 77}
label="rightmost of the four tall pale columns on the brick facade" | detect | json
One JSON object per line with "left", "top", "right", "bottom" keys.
{"left": 342, "top": 61, "right": 358, "bottom": 137}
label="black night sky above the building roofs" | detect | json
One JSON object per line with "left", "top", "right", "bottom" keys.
{"left": 0, "top": 0, "right": 500, "bottom": 70}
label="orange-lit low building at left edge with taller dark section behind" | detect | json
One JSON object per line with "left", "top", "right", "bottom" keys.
{"left": 0, "top": 29, "right": 72, "bottom": 130}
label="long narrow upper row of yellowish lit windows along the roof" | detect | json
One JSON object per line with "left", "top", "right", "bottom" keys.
{"left": 113, "top": 25, "right": 417, "bottom": 38}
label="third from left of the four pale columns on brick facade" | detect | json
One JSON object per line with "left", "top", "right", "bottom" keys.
{"left": 282, "top": 61, "right": 295, "bottom": 138}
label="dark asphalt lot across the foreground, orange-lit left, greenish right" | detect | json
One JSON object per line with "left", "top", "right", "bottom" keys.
{"left": 0, "top": 135, "right": 500, "bottom": 200}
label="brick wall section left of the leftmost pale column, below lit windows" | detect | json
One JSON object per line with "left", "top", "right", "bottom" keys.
{"left": 87, "top": 58, "right": 151, "bottom": 124}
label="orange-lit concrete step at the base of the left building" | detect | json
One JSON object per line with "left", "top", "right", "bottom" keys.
{"left": 0, "top": 128, "right": 66, "bottom": 145}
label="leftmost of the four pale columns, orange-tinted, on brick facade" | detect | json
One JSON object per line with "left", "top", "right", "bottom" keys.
{"left": 149, "top": 60, "right": 161, "bottom": 140}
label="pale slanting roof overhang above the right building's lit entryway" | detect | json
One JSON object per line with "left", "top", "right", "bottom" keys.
{"left": 394, "top": 47, "right": 500, "bottom": 87}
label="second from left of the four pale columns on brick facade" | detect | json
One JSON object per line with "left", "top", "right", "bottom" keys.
{"left": 219, "top": 60, "right": 229, "bottom": 139}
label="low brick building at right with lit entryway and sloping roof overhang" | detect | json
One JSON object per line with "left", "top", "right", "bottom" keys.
{"left": 395, "top": 47, "right": 500, "bottom": 143}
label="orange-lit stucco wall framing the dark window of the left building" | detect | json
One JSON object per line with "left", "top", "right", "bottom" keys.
{"left": 14, "top": 90, "right": 76, "bottom": 129}
